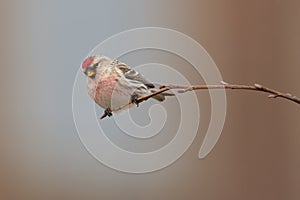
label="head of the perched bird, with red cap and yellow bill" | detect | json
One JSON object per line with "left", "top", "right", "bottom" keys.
{"left": 81, "top": 56, "right": 100, "bottom": 78}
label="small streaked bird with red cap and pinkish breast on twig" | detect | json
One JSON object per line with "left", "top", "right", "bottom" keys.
{"left": 81, "top": 55, "right": 174, "bottom": 119}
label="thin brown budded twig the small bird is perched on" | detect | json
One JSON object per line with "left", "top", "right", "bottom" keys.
{"left": 102, "top": 81, "right": 300, "bottom": 119}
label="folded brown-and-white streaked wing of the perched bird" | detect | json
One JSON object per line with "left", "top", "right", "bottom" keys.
{"left": 114, "top": 60, "right": 155, "bottom": 88}
